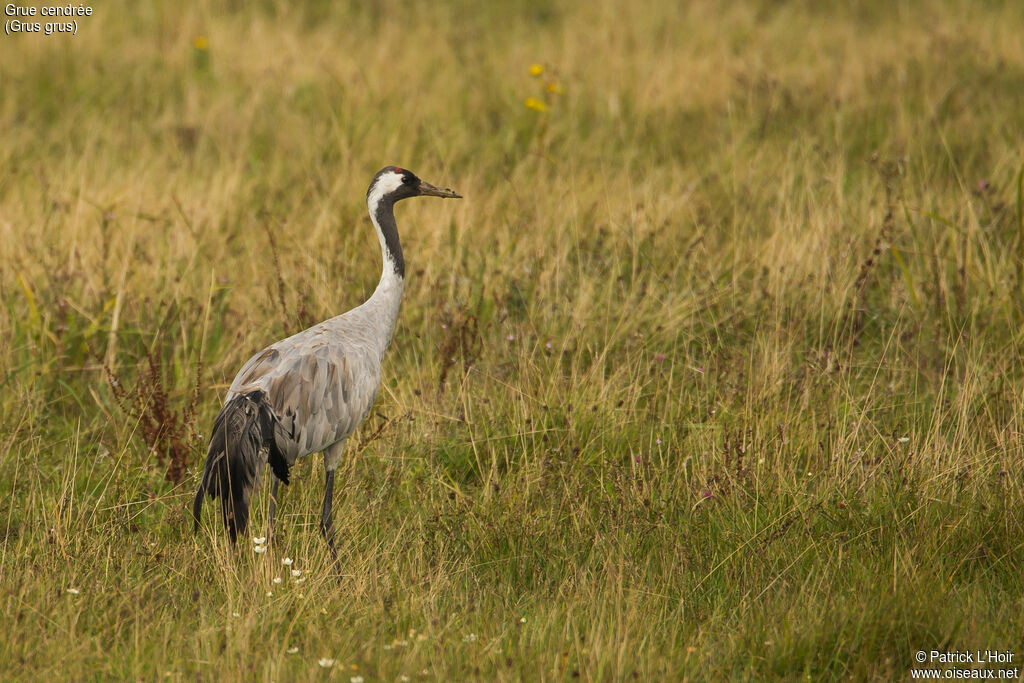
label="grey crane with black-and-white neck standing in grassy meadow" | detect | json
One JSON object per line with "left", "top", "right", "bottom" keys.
{"left": 193, "top": 166, "right": 461, "bottom": 560}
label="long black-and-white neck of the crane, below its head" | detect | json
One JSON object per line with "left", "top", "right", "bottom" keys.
{"left": 365, "top": 198, "right": 406, "bottom": 356}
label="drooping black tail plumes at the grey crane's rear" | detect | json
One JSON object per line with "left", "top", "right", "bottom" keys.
{"left": 193, "top": 389, "right": 288, "bottom": 543}
